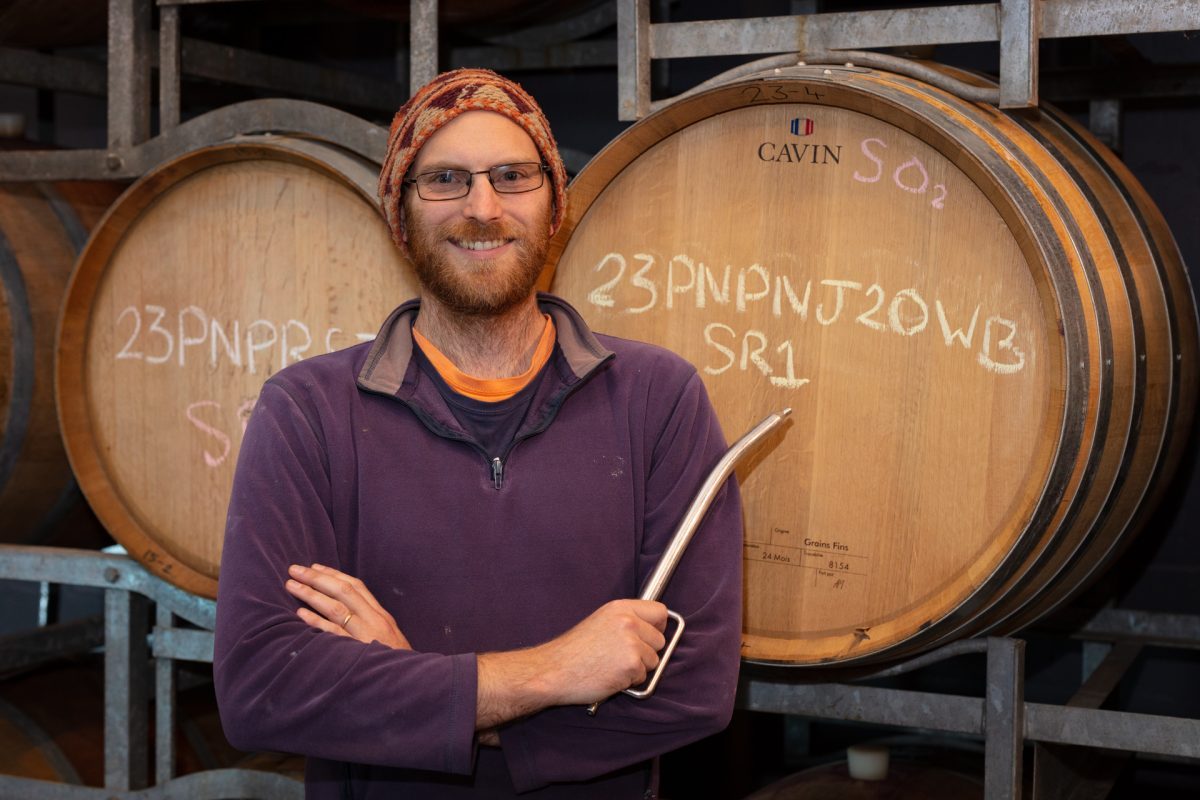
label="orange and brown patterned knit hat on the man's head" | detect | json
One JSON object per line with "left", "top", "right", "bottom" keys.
{"left": 379, "top": 70, "right": 566, "bottom": 255}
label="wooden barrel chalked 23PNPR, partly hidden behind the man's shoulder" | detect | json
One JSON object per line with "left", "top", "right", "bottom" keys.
{"left": 56, "top": 137, "right": 416, "bottom": 597}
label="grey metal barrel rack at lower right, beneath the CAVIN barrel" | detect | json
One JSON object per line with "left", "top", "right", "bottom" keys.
{"left": 738, "top": 609, "right": 1200, "bottom": 800}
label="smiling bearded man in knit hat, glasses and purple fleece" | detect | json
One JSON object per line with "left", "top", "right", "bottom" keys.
{"left": 214, "top": 70, "right": 742, "bottom": 800}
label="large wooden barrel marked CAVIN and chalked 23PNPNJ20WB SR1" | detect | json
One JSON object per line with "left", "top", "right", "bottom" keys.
{"left": 544, "top": 66, "right": 1198, "bottom": 667}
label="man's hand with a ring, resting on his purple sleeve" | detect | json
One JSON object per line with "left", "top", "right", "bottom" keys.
{"left": 284, "top": 564, "right": 413, "bottom": 650}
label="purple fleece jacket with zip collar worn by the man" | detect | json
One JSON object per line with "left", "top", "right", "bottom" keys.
{"left": 214, "top": 295, "right": 742, "bottom": 800}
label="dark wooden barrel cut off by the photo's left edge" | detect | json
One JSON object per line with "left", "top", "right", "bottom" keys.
{"left": 0, "top": 154, "right": 121, "bottom": 547}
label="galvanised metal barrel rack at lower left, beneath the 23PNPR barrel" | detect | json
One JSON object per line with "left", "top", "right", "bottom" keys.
{"left": 0, "top": 545, "right": 304, "bottom": 800}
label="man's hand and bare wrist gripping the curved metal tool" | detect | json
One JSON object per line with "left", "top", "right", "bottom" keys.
{"left": 475, "top": 600, "right": 667, "bottom": 728}
